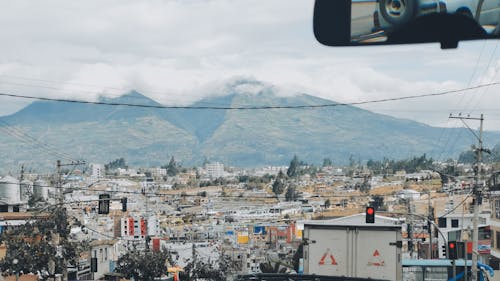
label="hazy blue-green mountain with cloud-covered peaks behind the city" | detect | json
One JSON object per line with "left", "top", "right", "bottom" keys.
{"left": 0, "top": 80, "right": 494, "bottom": 171}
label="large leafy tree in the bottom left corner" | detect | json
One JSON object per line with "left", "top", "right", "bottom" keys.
{"left": 0, "top": 207, "right": 88, "bottom": 274}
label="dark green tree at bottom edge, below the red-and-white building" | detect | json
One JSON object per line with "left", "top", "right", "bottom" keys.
{"left": 115, "top": 249, "right": 173, "bottom": 280}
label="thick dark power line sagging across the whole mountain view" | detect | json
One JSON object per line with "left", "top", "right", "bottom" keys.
{"left": 0, "top": 82, "right": 500, "bottom": 110}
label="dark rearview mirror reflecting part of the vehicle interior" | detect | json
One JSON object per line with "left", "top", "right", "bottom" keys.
{"left": 314, "top": 0, "right": 500, "bottom": 48}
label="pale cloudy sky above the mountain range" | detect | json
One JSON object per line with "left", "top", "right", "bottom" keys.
{"left": 0, "top": 0, "right": 500, "bottom": 130}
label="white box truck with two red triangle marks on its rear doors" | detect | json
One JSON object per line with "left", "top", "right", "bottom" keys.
{"left": 303, "top": 214, "right": 403, "bottom": 280}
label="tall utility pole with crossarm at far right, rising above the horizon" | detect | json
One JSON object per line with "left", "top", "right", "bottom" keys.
{"left": 450, "top": 114, "right": 484, "bottom": 281}
